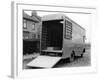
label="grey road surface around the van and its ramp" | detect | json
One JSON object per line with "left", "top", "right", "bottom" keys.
{"left": 23, "top": 48, "right": 91, "bottom": 69}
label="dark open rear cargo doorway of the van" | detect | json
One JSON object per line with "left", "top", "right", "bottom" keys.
{"left": 41, "top": 19, "right": 63, "bottom": 56}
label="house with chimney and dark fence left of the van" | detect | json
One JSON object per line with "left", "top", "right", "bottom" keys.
{"left": 23, "top": 11, "right": 41, "bottom": 54}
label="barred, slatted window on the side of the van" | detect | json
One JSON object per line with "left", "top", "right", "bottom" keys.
{"left": 65, "top": 20, "right": 72, "bottom": 40}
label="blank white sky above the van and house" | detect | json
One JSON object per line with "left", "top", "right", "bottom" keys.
{"left": 25, "top": 11, "right": 91, "bottom": 43}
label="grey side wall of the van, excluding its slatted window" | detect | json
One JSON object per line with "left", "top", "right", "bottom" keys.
{"left": 62, "top": 19, "right": 85, "bottom": 58}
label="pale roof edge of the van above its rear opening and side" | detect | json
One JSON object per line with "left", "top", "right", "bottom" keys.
{"left": 41, "top": 14, "right": 85, "bottom": 30}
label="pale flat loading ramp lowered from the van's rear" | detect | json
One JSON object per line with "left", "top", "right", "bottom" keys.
{"left": 27, "top": 56, "right": 61, "bottom": 68}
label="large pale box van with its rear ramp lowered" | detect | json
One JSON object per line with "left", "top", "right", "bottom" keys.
{"left": 28, "top": 14, "right": 85, "bottom": 68}
